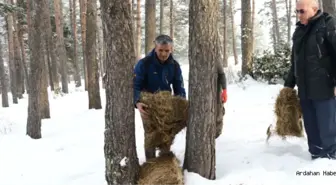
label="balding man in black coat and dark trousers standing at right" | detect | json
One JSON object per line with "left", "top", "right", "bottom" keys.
{"left": 284, "top": 0, "right": 336, "bottom": 159}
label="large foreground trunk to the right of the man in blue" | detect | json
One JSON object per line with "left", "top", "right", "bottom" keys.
{"left": 183, "top": 0, "right": 220, "bottom": 179}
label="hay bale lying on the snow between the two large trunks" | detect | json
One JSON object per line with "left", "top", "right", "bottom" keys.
{"left": 138, "top": 152, "right": 184, "bottom": 185}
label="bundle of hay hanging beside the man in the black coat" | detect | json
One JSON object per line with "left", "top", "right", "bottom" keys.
{"left": 267, "top": 87, "right": 303, "bottom": 140}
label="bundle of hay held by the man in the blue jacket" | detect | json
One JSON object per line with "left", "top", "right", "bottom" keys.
{"left": 140, "top": 91, "right": 188, "bottom": 151}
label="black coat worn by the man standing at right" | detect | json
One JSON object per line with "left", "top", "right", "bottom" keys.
{"left": 285, "top": 11, "right": 336, "bottom": 100}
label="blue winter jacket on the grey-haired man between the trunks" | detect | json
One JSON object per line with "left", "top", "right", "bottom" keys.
{"left": 133, "top": 50, "right": 186, "bottom": 105}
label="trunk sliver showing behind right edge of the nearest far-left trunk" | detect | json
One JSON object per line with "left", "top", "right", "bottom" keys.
{"left": 39, "top": 51, "right": 50, "bottom": 119}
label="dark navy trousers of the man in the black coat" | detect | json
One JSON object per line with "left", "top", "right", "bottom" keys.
{"left": 300, "top": 98, "right": 336, "bottom": 158}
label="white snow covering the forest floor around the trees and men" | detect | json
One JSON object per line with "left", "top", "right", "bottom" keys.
{"left": 0, "top": 62, "right": 336, "bottom": 185}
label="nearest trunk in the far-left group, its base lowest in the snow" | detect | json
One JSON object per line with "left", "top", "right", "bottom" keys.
{"left": 27, "top": 0, "right": 48, "bottom": 139}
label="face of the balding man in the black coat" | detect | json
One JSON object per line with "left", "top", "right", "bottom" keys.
{"left": 296, "top": 1, "right": 318, "bottom": 25}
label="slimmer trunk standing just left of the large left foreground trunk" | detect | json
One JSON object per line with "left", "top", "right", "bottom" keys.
{"left": 85, "top": 0, "right": 102, "bottom": 109}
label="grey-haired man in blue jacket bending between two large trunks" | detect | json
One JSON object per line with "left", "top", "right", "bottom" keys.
{"left": 134, "top": 35, "right": 186, "bottom": 160}
